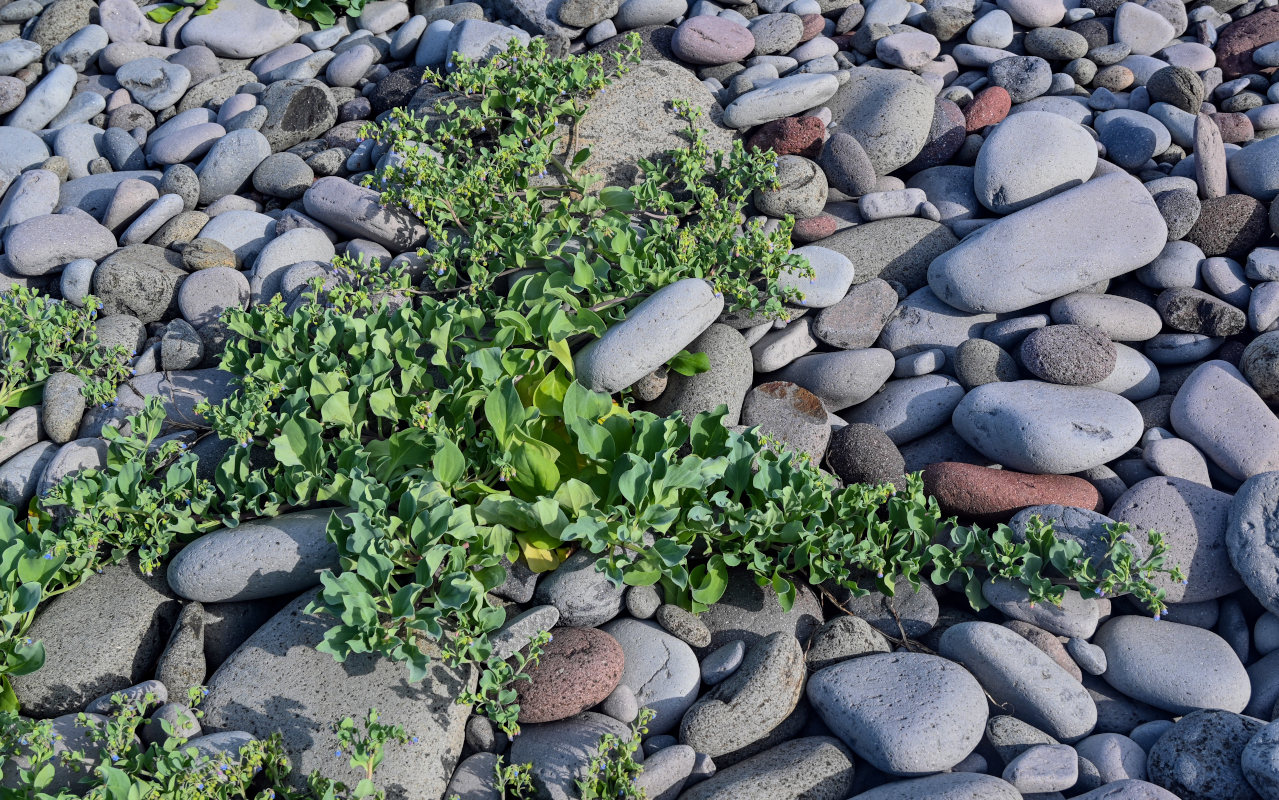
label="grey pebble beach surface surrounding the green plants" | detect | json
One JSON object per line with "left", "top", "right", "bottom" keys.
{"left": 0, "top": 0, "right": 1279, "bottom": 800}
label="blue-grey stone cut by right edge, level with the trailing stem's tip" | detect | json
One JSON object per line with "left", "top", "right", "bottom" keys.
{"left": 1225, "top": 472, "right": 1279, "bottom": 616}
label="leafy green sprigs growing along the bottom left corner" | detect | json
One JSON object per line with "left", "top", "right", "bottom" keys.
{"left": 0, "top": 689, "right": 404, "bottom": 800}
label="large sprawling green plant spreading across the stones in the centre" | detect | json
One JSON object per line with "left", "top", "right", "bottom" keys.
{"left": 0, "top": 37, "right": 1164, "bottom": 742}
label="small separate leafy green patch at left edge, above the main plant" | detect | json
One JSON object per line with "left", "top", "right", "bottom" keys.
{"left": 0, "top": 287, "right": 130, "bottom": 422}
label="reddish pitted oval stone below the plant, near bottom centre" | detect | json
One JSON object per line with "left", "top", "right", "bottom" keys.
{"left": 515, "top": 627, "right": 627, "bottom": 722}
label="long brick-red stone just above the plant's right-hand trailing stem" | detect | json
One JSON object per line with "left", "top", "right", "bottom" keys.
{"left": 923, "top": 461, "right": 1101, "bottom": 525}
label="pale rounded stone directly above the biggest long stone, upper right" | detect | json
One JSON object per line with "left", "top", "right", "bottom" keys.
{"left": 975, "top": 111, "right": 1097, "bottom": 214}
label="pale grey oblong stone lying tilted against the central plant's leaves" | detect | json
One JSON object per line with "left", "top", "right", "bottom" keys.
{"left": 574, "top": 278, "right": 724, "bottom": 392}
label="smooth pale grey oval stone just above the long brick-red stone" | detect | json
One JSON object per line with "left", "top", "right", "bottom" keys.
{"left": 952, "top": 380, "right": 1145, "bottom": 475}
